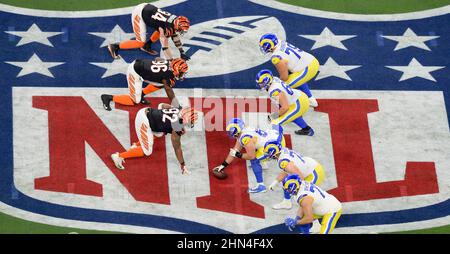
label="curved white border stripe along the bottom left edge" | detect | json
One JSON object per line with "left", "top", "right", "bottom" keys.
{"left": 0, "top": 202, "right": 180, "bottom": 234}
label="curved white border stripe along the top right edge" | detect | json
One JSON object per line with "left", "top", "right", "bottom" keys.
{"left": 249, "top": 0, "right": 450, "bottom": 21}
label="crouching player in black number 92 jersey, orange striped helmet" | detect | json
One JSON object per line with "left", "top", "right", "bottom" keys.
{"left": 111, "top": 103, "right": 198, "bottom": 175}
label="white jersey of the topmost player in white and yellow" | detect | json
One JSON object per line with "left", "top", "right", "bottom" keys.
{"left": 271, "top": 41, "right": 314, "bottom": 73}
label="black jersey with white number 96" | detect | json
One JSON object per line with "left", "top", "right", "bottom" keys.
{"left": 134, "top": 59, "right": 175, "bottom": 87}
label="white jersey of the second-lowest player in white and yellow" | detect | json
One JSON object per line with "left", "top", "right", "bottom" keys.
{"left": 277, "top": 148, "right": 319, "bottom": 177}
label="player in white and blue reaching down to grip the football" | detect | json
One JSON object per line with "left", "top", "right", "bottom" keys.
{"left": 213, "top": 118, "right": 285, "bottom": 193}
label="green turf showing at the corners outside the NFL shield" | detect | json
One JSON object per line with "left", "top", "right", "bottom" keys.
{"left": 0, "top": 0, "right": 450, "bottom": 234}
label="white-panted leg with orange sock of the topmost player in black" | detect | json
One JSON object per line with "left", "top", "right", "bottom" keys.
{"left": 108, "top": 3, "right": 147, "bottom": 58}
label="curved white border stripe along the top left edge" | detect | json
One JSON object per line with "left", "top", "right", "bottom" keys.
{"left": 0, "top": 0, "right": 186, "bottom": 18}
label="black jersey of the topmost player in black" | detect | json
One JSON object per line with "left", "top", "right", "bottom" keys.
{"left": 142, "top": 4, "right": 177, "bottom": 30}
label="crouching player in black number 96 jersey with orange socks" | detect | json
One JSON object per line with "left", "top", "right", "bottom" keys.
{"left": 101, "top": 58, "right": 188, "bottom": 111}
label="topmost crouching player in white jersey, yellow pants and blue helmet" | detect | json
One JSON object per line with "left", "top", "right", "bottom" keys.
{"left": 259, "top": 33, "right": 319, "bottom": 107}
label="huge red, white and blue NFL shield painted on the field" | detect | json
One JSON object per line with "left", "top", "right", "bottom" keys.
{"left": 0, "top": 0, "right": 450, "bottom": 233}
